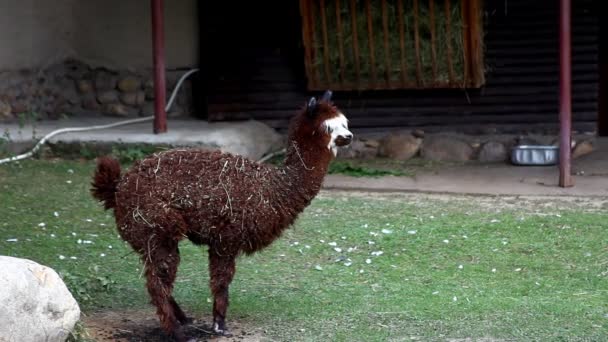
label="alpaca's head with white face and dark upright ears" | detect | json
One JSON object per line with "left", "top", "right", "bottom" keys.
{"left": 290, "top": 90, "right": 353, "bottom": 157}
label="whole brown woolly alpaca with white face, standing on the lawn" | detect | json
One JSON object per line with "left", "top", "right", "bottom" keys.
{"left": 91, "top": 91, "right": 352, "bottom": 341}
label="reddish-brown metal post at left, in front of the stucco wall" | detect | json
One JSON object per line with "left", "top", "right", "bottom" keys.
{"left": 151, "top": 0, "right": 167, "bottom": 134}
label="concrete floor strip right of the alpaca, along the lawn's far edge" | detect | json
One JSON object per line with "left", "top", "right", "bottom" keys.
{"left": 324, "top": 138, "right": 608, "bottom": 197}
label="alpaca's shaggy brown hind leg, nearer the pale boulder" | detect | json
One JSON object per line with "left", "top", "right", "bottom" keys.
{"left": 144, "top": 241, "right": 186, "bottom": 342}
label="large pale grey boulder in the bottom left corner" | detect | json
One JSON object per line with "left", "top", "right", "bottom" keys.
{"left": 0, "top": 256, "right": 80, "bottom": 342}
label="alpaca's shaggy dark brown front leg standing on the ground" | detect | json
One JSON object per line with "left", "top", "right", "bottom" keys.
{"left": 209, "top": 249, "right": 236, "bottom": 335}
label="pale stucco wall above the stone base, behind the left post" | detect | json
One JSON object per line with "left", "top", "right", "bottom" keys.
{"left": 0, "top": 0, "right": 198, "bottom": 70}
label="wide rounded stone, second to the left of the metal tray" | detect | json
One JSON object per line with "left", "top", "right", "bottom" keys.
{"left": 421, "top": 135, "right": 473, "bottom": 162}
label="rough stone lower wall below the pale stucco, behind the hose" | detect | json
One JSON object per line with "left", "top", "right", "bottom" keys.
{"left": 0, "top": 60, "right": 193, "bottom": 122}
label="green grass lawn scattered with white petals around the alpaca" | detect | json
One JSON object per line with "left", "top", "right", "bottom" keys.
{"left": 0, "top": 160, "right": 608, "bottom": 341}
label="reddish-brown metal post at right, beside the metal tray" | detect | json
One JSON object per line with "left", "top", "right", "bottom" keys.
{"left": 559, "top": 0, "right": 574, "bottom": 188}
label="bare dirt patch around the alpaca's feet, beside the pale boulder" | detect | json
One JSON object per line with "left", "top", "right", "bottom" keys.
{"left": 82, "top": 310, "right": 264, "bottom": 342}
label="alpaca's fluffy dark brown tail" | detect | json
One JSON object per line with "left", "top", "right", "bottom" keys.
{"left": 91, "top": 157, "right": 120, "bottom": 210}
